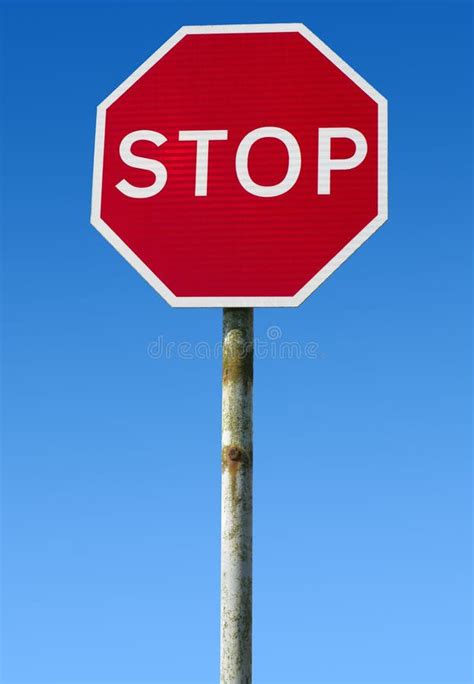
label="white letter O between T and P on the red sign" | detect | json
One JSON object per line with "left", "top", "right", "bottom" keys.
{"left": 235, "top": 126, "right": 301, "bottom": 197}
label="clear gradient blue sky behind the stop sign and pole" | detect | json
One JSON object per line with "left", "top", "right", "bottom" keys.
{"left": 1, "top": 2, "right": 472, "bottom": 684}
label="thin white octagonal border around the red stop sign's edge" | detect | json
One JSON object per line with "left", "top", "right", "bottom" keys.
{"left": 91, "top": 24, "right": 388, "bottom": 307}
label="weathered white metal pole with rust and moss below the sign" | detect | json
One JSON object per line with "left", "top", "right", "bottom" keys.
{"left": 221, "top": 309, "right": 253, "bottom": 684}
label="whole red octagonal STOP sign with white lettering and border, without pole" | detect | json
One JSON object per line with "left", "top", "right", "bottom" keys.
{"left": 92, "top": 24, "right": 387, "bottom": 306}
